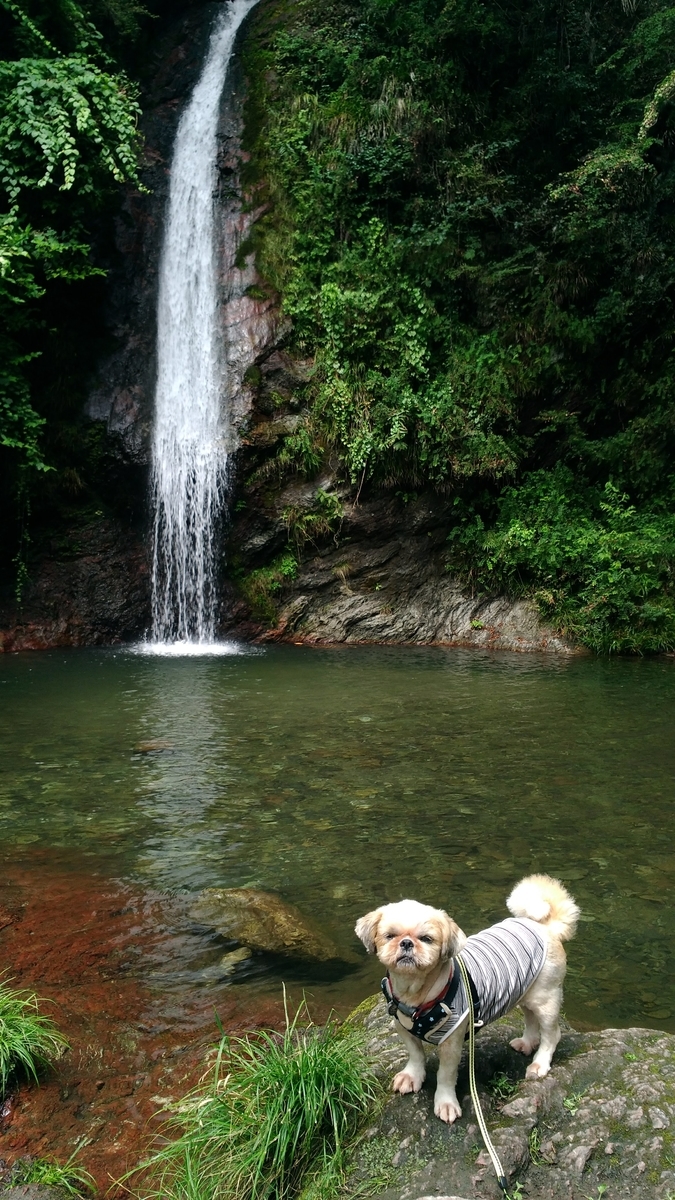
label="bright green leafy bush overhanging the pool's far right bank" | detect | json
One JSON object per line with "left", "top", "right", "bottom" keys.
{"left": 450, "top": 466, "right": 675, "bottom": 653}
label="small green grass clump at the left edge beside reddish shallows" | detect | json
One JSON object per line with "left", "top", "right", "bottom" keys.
{"left": 0, "top": 979, "right": 68, "bottom": 1097}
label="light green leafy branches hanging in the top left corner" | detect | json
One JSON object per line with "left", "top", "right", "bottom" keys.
{"left": 0, "top": 0, "right": 141, "bottom": 470}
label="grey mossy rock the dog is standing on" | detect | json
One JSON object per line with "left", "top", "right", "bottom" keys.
{"left": 352, "top": 998, "right": 675, "bottom": 1200}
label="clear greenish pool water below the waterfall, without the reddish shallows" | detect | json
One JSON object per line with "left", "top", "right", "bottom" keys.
{"left": 0, "top": 647, "right": 675, "bottom": 1028}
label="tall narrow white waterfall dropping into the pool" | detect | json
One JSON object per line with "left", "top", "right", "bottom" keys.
{"left": 151, "top": 0, "right": 256, "bottom": 646}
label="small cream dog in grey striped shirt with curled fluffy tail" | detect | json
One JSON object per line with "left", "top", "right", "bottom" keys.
{"left": 356, "top": 875, "right": 579, "bottom": 1124}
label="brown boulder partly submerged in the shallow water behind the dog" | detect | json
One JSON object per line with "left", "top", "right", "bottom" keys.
{"left": 190, "top": 888, "right": 344, "bottom": 962}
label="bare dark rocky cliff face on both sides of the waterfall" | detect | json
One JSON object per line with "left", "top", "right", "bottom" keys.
{"left": 0, "top": 5, "right": 571, "bottom": 653}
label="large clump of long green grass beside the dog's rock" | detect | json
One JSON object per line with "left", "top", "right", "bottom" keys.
{"left": 141, "top": 1004, "right": 380, "bottom": 1200}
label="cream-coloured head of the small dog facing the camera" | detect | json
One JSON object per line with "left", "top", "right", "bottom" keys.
{"left": 356, "top": 900, "right": 460, "bottom": 976}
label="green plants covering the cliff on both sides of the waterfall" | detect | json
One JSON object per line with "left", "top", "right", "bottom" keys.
{"left": 0, "top": 0, "right": 675, "bottom": 653}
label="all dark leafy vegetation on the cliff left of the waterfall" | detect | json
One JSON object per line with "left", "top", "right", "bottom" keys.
{"left": 0, "top": 0, "right": 148, "bottom": 593}
